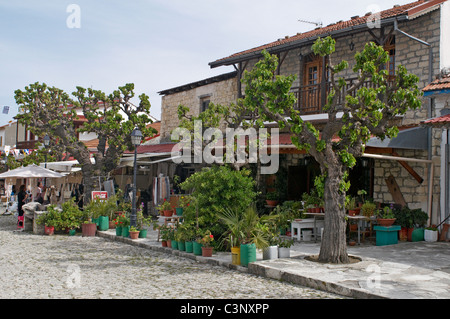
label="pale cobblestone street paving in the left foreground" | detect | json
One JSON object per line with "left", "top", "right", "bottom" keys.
{"left": 0, "top": 216, "right": 342, "bottom": 299}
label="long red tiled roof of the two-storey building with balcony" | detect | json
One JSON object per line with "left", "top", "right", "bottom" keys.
{"left": 210, "top": 0, "right": 446, "bottom": 67}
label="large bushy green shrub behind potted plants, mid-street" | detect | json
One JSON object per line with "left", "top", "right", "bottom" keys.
{"left": 181, "top": 166, "right": 257, "bottom": 237}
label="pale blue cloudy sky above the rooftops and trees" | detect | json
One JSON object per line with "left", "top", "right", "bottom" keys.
{"left": 0, "top": 0, "right": 414, "bottom": 126}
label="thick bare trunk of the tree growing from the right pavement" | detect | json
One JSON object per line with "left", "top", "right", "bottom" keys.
{"left": 319, "top": 163, "right": 349, "bottom": 264}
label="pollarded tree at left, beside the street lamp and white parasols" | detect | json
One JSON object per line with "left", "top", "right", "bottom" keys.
{"left": 15, "top": 82, "right": 155, "bottom": 202}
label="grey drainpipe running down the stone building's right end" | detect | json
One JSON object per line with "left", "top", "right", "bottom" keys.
{"left": 394, "top": 20, "right": 434, "bottom": 223}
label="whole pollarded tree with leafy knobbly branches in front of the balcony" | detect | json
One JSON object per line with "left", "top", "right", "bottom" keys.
{"left": 176, "top": 37, "right": 421, "bottom": 263}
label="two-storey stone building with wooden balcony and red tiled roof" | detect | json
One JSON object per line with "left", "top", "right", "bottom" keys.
{"left": 160, "top": 0, "right": 450, "bottom": 223}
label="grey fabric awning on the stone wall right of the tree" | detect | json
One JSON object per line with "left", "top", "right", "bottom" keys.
{"left": 366, "top": 127, "right": 428, "bottom": 150}
